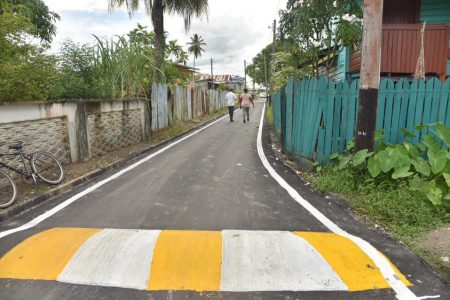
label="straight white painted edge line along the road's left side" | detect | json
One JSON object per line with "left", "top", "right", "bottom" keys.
{"left": 0, "top": 111, "right": 232, "bottom": 239}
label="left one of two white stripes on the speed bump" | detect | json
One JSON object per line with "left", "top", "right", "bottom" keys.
{"left": 57, "top": 229, "right": 161, "bottom": 290}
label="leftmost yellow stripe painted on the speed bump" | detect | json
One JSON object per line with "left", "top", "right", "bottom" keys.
{"left": 0, "top": 228, "right": 101, "bottom": 280}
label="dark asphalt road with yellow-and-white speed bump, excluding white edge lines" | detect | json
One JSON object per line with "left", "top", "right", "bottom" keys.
{"left": 0, "top": 103, "right": 450, "bottom": 299}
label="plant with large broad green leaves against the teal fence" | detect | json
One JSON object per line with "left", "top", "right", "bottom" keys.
{"left": 331, "top": 123, "right": 450, "bottom": 210}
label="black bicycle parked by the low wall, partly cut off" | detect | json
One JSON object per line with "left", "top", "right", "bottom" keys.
{"left": 0, "top": 142, "right": 64, "bottom": 208}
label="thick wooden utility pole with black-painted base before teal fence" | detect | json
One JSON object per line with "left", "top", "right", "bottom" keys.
{"left": 355, "top": 0, "right": 383, "bottom": 151}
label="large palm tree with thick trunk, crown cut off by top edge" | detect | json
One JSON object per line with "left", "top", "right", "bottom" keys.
{"left": 108, "top": 0, "right": 208, "bottom": 82}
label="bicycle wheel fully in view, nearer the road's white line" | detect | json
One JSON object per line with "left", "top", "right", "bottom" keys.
{"left": 31, "top": 152, "right": 64, "bottom": 184}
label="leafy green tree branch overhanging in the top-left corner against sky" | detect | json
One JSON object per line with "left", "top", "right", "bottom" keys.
{"left": 0, "top": 0, "right": 60, "bottom": 43}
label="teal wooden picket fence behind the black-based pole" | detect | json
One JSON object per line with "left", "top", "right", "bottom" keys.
{"left": 272, "top": 78, "right": 450, "bottom": 163}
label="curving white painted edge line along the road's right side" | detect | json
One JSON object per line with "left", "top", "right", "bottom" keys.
{"left": 256, "top": 103, "right": 419, "bottom": 300}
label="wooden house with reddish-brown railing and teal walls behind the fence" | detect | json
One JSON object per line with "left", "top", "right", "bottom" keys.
{"left": 330, "top": 0, "right": 450, "bottom": 80}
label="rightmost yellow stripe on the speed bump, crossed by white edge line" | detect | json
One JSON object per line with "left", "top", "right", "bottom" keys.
{"left": 294, "top": 232, "right": 411, "bottom": 291}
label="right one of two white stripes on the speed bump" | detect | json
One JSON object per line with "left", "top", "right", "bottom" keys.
{"left": 220, "top": 230, "right": 348, "bottom": 292}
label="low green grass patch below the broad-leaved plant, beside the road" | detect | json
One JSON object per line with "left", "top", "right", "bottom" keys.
{"left": 309, "top": 167, "right": 448, "bottom": 237}
